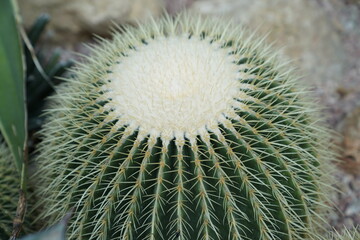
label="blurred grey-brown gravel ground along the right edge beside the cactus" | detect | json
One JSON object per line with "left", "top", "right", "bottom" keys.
{"left": 318, "top": 0, "right": 360, "bottom": 231}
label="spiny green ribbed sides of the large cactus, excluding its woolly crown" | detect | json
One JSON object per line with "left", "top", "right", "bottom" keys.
{"left": 33, "top": 13, "right": 331, "bottom": 239}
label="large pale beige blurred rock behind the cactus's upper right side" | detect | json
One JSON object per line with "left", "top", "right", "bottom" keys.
{"left": 191, "top": 0, "right": 347, "bottom": 86}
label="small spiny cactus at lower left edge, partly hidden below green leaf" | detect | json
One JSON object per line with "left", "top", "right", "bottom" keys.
{"left": 0, "top": 141, "right": 19, "bottom": 240}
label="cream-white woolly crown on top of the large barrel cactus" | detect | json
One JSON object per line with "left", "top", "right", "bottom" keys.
{"left": 103, "top": 36, "right": 242, "bottom": 140}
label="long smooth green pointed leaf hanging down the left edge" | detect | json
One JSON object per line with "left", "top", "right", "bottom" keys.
{"left": 0, "top": 0, "right": 27, "bottom": 172}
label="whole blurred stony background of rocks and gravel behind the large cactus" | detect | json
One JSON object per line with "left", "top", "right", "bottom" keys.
{"left": 18, "top": 0, "right": 360, "bottom": 234}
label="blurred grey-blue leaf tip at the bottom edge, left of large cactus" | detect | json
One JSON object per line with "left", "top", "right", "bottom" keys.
{"left": 20, "top": 213, "right": 71, "bottom": 240}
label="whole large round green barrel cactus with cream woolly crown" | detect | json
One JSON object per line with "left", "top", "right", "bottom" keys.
{"left": 36, "top": 14, "right": 330, "bottom": 240}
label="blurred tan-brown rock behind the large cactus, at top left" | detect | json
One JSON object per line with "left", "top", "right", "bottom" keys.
{"left": 18, "top": 0, "right": 165, "bottom": 41}
